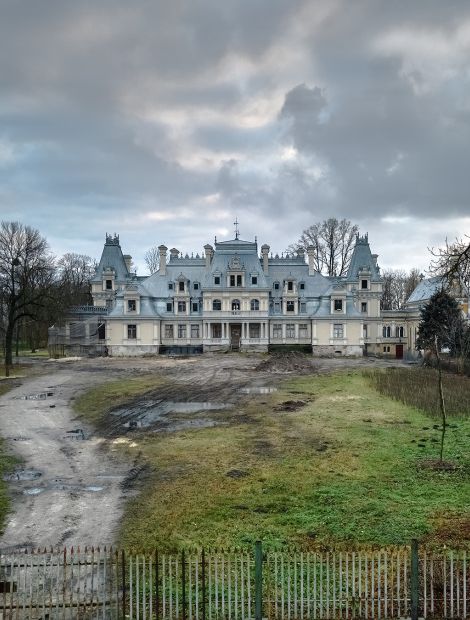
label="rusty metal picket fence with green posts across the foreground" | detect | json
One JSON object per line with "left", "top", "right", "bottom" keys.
{"left": 0, "top": 543, "right": 470, "bottom": 620}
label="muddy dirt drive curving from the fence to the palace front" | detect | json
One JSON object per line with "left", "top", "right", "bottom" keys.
{"left": 0, "top": 354, "right": 408, "bottom": 549}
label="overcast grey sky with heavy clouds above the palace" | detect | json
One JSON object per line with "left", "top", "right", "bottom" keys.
{"left": 0, "top": 0, "right": 470, "bottom": 275}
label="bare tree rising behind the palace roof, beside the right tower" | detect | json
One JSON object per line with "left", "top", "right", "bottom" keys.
{"left": 287, "top": 218, "right": 359, "bottom": 276}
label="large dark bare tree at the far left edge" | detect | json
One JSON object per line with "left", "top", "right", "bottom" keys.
{"left": 0, "top": 222, "right": 54, "bottom": 376}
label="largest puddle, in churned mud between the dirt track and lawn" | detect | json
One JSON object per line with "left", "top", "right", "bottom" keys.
{"left": 111, "top": 400, "right": 233, "bottom": 430}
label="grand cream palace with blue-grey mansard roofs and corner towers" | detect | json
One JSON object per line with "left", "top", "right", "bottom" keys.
{"left": 50, "top": 232, "right": 436, "bottom": 358}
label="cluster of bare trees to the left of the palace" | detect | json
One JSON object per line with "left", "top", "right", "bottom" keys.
{"left": 0, "top": 222, "right": 96, "bottom": 376}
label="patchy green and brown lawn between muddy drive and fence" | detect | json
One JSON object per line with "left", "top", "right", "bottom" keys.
{"left": 73, "top": 370, "right": 470, "bottom": 549}
